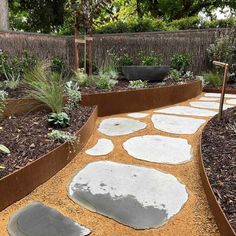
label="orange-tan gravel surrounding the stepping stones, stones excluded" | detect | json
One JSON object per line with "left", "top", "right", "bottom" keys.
{"left": 0, "top": 94, "right": 220, "bottom": 236}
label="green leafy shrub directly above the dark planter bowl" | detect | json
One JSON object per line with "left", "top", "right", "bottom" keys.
{"left": 139, "top": 51, "right": 163, "bottom": 66}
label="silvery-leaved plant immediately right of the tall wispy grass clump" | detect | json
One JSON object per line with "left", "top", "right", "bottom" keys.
{"left": 65, "top": 81, "right": 81, "bottom": 110}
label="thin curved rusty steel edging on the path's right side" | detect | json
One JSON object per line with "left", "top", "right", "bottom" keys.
{"left": 200, "top": 127, "right": 236, "bottom": 236}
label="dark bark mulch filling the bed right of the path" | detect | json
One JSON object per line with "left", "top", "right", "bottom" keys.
{"left": 202, "top": 108, "right": 236, "bottom": 231}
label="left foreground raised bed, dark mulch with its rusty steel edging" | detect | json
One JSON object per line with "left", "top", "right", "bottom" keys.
{"left": 0, "top": 106, "right": 97, "bottom": 210}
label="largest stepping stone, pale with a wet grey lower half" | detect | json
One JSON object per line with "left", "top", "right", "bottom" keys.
{"left": 68, "top": 161, "right": 188, "bottom": 229}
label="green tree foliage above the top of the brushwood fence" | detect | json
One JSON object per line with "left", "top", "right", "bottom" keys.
{"left": 6, "top": 0, "right": 236, "bottom": 34}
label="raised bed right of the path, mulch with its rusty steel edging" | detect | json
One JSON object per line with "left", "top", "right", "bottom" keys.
{"left": 201, "top": 108, "right": 236, "bottom": 236}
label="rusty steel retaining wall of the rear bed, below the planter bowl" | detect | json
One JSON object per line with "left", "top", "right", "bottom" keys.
{"left": 81, "top": 80, "right": 202, "bottom": 116}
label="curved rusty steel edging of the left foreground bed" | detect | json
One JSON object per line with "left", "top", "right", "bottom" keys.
{"left": 0, "top": 107, "right": 97, "bottom": 211}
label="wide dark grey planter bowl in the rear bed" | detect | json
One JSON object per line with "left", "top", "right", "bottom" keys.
{"left": 122, "top": 66, "right": 170, "bottom": 82}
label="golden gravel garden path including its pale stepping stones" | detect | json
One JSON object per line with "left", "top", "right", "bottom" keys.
{"left": 0, "top": 93, "right": 226, "bottom": 236}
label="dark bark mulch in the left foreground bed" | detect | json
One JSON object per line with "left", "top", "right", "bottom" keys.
{"left": 0, "top": 106, "right": 94, "bottom": 178}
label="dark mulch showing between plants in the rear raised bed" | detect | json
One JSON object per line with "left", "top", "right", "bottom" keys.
{"left": 6, "top": 79, "right": 196, "bottom": 98}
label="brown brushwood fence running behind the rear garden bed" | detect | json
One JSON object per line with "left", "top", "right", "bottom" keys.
{"left": 0, "top": 29, "right": 230, "bottom": 73}
